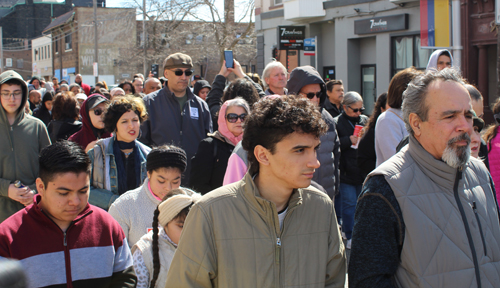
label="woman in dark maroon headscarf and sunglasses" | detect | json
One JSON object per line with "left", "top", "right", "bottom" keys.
{"left": 68, "top": 94, "right": 111, "bottom": 152}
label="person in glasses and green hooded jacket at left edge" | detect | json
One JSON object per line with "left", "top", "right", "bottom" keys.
{"left": 0, "top": 70, "right": 50, "bottom": 223}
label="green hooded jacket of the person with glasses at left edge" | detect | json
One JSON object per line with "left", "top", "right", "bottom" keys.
{"left": 0, "top": 70, "right": 50, "bottom": 222}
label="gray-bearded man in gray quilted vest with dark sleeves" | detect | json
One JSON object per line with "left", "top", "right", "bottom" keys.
{"left": 349, "top": 69, "right": 500, "bottom": 287}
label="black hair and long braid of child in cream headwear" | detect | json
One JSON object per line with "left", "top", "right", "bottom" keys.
{"left": 149, "top": 188, "right": 193, "bottom": 287}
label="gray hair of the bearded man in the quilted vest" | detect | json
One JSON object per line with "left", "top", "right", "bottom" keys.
{"left": 401, "top": 68, "right": 465, "bottom": 135}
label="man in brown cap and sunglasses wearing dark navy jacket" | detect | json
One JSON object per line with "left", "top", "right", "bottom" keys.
{"left": 140, "top": 53, "right": 212, "bottom": 186}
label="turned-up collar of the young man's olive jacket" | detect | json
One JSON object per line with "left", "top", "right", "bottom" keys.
{"left": 242, "top": 173, "right": 302, "bottom": 217}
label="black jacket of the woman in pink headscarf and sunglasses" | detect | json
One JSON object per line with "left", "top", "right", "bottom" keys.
{"left": 190, "top": 136, "right": 234, "bottom": 194}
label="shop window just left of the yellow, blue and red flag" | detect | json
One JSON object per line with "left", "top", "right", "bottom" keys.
{"left": 392, "top": 35, "right": 432, "bottom": 75}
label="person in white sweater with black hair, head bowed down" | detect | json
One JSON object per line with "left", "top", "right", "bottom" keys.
{"left": 109, "top": 145, "right": 194, "bottom": 247}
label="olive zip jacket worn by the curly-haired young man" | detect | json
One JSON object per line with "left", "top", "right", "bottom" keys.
{"left": 165, "top": 174, "right": 346, "bottom": 288}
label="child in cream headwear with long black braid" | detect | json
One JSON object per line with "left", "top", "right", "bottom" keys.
{"left": 132, "top": 189, "right": 201, "bottom": 288}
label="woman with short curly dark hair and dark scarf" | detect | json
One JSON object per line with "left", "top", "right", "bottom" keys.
{"left": 88, "top": 96, "right": 151, "bottom": 210}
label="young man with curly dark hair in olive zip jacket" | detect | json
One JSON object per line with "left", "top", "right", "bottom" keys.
{"left": 165, "top": 96, "right": 346, "bottom": 287}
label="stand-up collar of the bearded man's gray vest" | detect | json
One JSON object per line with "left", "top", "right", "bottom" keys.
{"left": 407, "top": 135, "right": 457, "bottom": 192}
